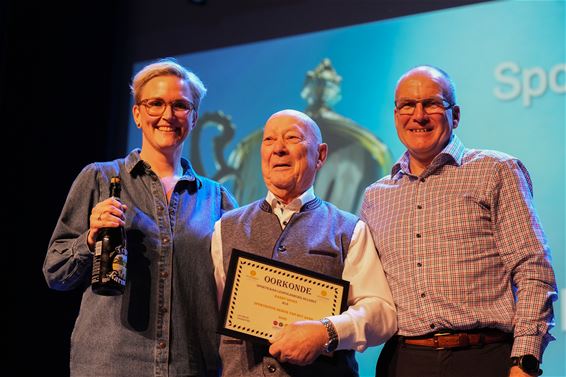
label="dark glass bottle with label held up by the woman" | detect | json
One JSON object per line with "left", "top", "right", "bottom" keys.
{"left": 91, "top": 177, "right": 128, "bottom": 296}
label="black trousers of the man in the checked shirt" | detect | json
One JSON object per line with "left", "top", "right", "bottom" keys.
{"left": 375, "top": 336, "right": 512, "bottom": 377}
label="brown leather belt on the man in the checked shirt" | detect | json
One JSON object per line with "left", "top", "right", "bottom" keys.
{"left": 400, "top": 329, "right": 512, "bottom": 350}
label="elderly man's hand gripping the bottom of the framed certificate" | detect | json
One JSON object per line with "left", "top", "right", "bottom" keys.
{"left": 269, "top": 321, "right": 328, "bottom": 365}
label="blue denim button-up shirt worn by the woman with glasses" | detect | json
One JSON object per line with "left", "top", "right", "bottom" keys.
{"left": 43, "top": 149, "right": 236, "bottom": 377}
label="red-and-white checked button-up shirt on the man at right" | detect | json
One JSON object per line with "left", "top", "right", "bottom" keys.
{"left": 361, "top": 136, "right": 557, "bottom": 359}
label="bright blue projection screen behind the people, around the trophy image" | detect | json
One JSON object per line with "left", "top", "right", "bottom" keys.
{"left": 128, "top": 1, "right": 566, "bottom": 376}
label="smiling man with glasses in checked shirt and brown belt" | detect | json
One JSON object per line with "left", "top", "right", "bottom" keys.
{"left": 361, "top": 66, "right": 557, "bottom": 377}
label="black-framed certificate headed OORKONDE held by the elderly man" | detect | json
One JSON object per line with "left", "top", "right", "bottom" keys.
{"left": 218, "top": 250, "right": 350, "bottom": 343}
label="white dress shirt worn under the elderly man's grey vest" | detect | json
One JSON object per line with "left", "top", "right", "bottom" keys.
{"left": 211, "top": 187, "right": 397, "bottom": 352}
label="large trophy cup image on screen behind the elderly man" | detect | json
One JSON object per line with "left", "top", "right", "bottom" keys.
{"left": 190, "top": 58, "right": 392, "bottom": 213}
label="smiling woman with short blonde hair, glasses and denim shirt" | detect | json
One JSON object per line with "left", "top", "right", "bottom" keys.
{"left": 43, "top": 59, "right": 236, "bottom": 376}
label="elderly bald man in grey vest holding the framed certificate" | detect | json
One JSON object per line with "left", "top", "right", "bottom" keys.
{"left": 212, "top": 110, "right": 397, "bottom": 377}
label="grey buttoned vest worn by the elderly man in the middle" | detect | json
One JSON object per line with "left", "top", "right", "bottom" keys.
{"left": 220, "top": 198, "right": 358, "bottom": 377}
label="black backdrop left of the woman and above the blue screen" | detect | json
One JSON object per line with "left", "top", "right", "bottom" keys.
{"left": 0, "top": 0, "right": 492, "bottom": 376}
